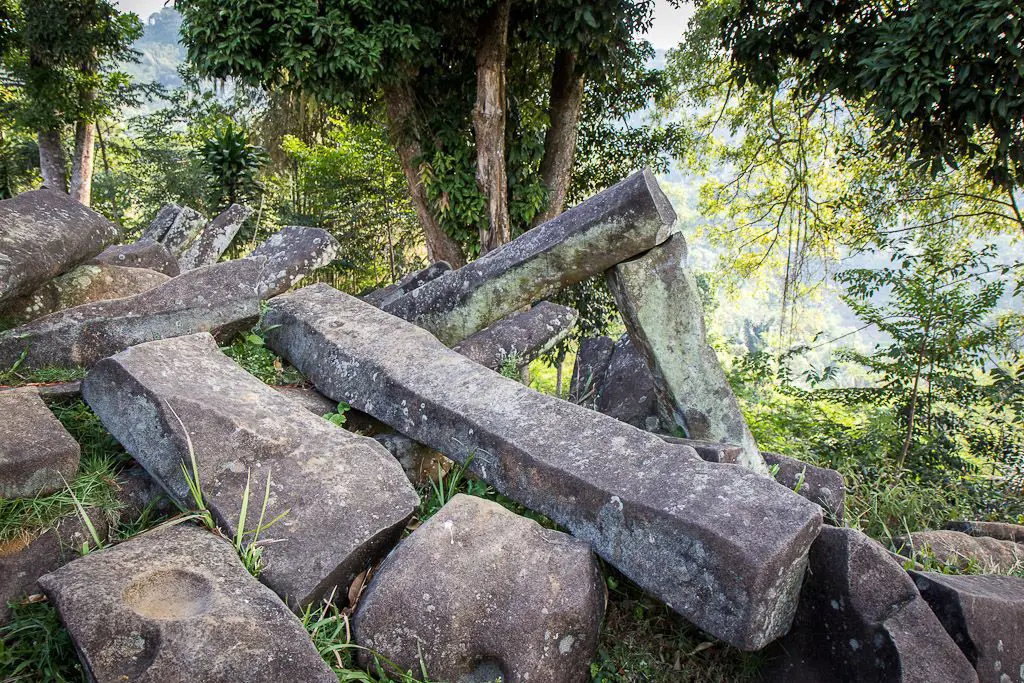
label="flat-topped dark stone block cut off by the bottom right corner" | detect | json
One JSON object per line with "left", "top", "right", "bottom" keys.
{"left": 910, "top": 571, "right": 1024, "bottom": 683}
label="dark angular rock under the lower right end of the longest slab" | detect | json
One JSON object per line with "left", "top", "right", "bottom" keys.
{"left": 761, "top": 527, "right": 978, "bottom": 683}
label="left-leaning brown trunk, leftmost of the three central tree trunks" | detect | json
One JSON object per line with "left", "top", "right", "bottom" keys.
{"left": 384, "top": 86, "right": 466, "bottom": 268}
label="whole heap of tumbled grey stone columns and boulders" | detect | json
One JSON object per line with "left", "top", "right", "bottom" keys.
{"left": 0, "top": 178, "right": 1024, "bottom": 683}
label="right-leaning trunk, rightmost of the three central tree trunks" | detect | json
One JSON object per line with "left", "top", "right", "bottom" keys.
{"left": 534, "top": 50, "right": 584, "bottom": 226}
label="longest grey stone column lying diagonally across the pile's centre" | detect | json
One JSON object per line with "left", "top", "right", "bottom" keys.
{"left": 264, "top": 285, "right": 821, "bottom": 649}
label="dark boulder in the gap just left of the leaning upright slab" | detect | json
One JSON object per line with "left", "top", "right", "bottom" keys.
{"left": 594, "top": 335, "right": 672, "bottom": 432}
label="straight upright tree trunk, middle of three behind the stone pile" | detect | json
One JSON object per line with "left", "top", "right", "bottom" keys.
{"left": 473, "top": 0, "right": 512, "bottom": 256}
